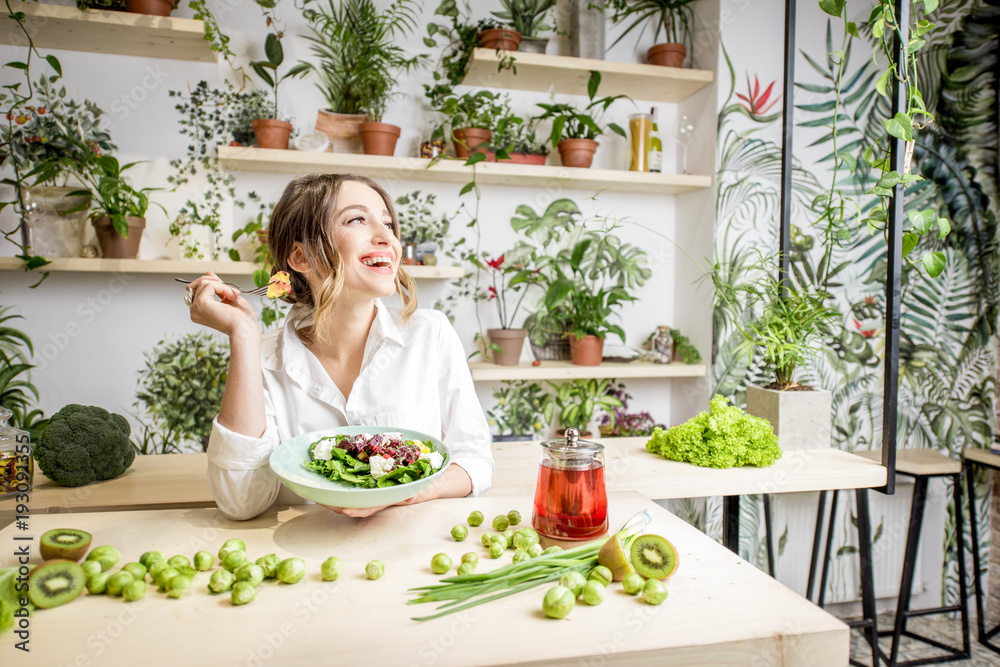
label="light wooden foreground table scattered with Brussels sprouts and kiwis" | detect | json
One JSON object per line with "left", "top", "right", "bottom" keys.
{"left": 0, "top": 493, "right": 849, "bottom": 667}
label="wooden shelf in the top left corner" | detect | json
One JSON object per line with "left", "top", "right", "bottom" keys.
{"left": 0, "top": 1, "right": 218, "bottom": 63}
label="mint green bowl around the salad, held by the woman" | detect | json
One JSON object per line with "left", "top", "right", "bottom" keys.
{"left": 268, "top": 426, "right": 451, "bottom": 508}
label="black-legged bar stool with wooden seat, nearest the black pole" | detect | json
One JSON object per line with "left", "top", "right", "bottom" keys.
{"left": 844, "top": 449, "right": 971, "bottom": 667}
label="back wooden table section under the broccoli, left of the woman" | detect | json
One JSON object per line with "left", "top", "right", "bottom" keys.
{"left": 0, "top": 454, "right": 215, "bottom": 526}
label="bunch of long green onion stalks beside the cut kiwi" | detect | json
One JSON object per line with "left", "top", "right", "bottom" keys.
{"left": 408, "top": 512, "right": 652, "bottom": 621}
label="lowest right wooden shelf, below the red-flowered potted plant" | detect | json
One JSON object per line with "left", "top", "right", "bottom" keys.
{"left": 469, "top": 361, "right": 708, "bottom": 382}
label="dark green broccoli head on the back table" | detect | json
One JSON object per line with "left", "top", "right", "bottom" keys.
{"left": 34, "top": 404, "right": 135, "bottom": 486}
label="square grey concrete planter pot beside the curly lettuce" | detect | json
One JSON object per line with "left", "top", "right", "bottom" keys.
{"left": 747, "top": 385, "right": 832, "bottom": 451}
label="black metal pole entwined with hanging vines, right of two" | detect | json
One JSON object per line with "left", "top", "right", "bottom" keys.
{"left": 878, "top": 0, "right": 910, "bottom": 494}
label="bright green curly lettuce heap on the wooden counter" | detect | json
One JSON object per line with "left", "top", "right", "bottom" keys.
{"left": 646, "top": 396, "right": 781, "bottom": 468}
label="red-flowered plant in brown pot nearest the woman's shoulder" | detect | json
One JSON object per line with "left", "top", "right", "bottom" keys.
{"left": 467, "top": 251, "right": 541, "bottom": 366}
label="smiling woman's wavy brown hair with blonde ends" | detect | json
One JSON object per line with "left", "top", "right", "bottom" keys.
{"left": 267, "top": 174, "right": 417, "bottom": 342}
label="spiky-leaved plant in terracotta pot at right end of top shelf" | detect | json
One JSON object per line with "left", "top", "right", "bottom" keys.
{"left": 607, "top": 0, "right": 694, "bottom": 67}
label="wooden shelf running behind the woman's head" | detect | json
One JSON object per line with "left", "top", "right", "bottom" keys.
{"left": 0, "top": 257, "right": 464, "bottom": 280}
